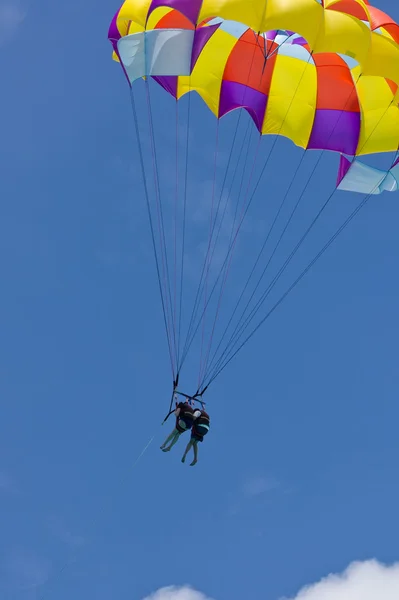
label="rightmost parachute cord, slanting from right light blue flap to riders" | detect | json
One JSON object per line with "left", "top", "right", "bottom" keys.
{"left": 206, "top": 150, "right": 399, "bottom": 388}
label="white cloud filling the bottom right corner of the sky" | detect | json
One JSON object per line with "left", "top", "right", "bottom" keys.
{"left": 291, "top": 560, "right": 399, "bottom": 600}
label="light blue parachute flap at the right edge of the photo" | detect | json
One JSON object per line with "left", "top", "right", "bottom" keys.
{"left": 337, "top": 155, "right": 399, "bottom": 195}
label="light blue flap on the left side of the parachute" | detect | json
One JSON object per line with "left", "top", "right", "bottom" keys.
{"left": 118, "top": 29, "right": 195, "bottom": 84}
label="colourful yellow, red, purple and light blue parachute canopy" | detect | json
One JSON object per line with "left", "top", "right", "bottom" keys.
{"left": 109, "top": 0, "right": 399, "bottom": 396}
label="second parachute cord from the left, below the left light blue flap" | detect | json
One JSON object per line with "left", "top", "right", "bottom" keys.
{"left": 145, "top": 78, "right": 177, "bottom": 377}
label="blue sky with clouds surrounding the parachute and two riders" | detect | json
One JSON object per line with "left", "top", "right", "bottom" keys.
{"left": 0, "top": 0, "right": 399, "bottom": 600}
